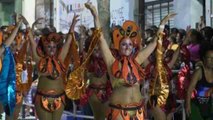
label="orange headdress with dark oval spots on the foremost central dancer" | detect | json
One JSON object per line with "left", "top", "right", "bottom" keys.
{"left": 113, "top": 20, "right": 141, "bottom": 50}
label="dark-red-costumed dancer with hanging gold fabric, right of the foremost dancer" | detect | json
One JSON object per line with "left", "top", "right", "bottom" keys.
{"left": 146, "top": 33, "right": 180, "bottom": 120}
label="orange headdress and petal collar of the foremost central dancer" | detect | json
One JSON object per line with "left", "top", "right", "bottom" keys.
{"left": 112, "top": 21, "right": 144, "bottom": 86}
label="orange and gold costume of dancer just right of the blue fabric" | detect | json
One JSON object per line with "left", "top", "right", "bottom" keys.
{"left": 14, "top": 31, "right": 33, "bottom": 104}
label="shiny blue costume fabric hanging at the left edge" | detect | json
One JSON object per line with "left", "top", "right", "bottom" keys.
{"left": 0, "top": 45, "right": 16, "bottom": 115}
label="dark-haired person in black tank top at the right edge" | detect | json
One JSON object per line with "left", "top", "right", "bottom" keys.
{"left": 186, "top": 44, "right": 213, "bottom": 120}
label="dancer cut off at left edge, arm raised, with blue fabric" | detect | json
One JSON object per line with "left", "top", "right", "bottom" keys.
{"left": 0, "top": 18, "right": 23, "bottom": 116}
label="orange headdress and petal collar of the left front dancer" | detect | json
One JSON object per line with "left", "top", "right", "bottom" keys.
{"left": 37, "top": 33, "right": 65, "bottom": 79}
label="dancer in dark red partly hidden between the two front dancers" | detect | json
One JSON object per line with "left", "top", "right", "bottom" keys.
{"left": 80, "top": 41, "right": 112, "bottom": 120}
